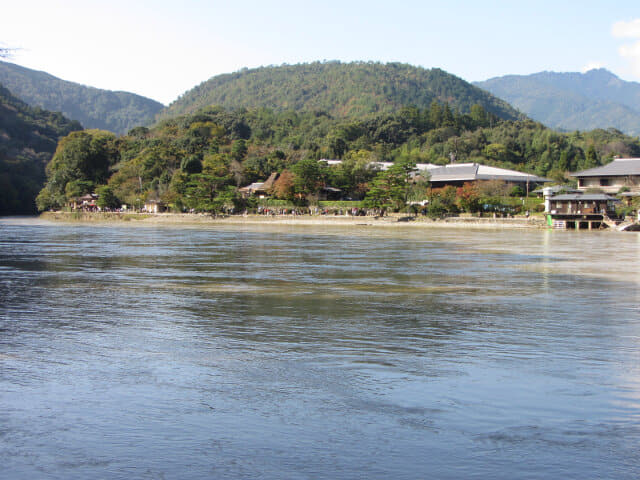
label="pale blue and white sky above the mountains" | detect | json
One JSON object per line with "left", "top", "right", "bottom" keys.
{"left": 0, "top": 0, "right": 640, "bottom": 104}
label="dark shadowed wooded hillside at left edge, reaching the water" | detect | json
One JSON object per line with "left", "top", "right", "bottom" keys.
{"left": 0, "top": 85, "right": 81, "bottom": 215}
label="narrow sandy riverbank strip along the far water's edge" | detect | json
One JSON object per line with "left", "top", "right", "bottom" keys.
{"left": 40, "top": 212, "right": 546, "bottom": 229}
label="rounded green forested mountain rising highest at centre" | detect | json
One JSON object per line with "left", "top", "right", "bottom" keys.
{"left": 159, "top": 62, "right": 523, "bottom": 120}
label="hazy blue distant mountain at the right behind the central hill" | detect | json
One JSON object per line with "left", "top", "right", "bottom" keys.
{"left": 475, "top": 69, "right": 640, "bottom": 135}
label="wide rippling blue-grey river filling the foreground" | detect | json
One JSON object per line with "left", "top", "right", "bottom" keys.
{"left": 0, "top": 219, "right": 640, "bottom": 479}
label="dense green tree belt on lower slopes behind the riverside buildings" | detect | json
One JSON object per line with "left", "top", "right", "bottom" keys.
{"left": 38, "top": 101, "right": 640, "bottom": 216}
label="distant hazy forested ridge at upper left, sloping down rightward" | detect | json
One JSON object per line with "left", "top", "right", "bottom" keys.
{"left": 0, "top": 62, "right": 163, "bottom": 134}
